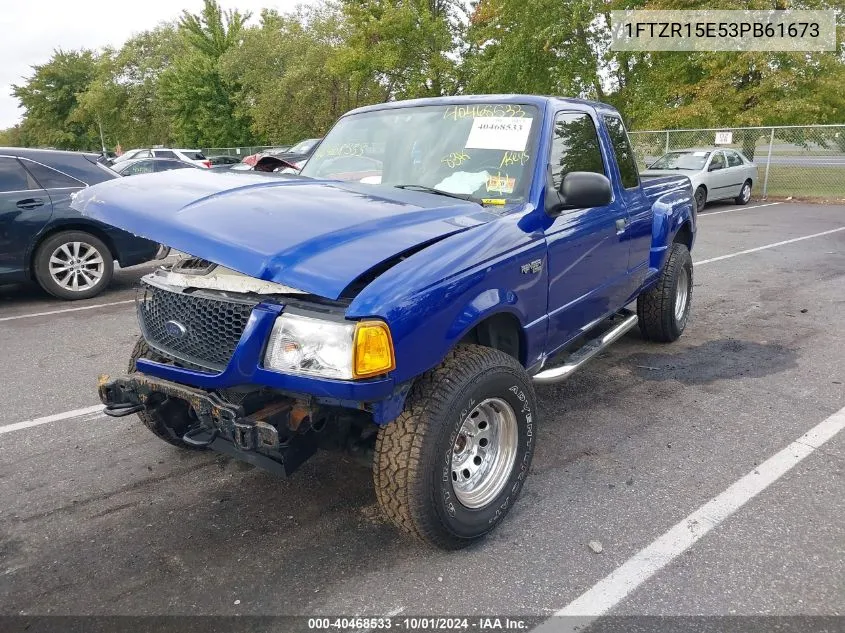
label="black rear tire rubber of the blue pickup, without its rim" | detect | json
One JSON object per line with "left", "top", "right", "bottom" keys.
{"left": 637, "top": 243, "right": 693, "bottom": 343}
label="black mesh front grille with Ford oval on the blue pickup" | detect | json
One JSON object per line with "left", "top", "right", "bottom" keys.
{"left": 137, "top": 284, "right": 258, "bottom": 371}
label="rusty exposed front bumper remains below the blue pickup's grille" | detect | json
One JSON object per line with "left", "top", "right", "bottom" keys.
{"left": 98, "top": 374, "right": 325, "bottom": 476}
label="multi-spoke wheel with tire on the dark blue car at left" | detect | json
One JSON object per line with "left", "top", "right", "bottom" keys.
{"left": 34, "top": 231, "right": 114, "bottom": 301}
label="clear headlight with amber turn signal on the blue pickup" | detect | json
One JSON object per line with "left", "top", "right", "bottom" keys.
{"left": 264, "top": 314, "right": 396, "bottom": 380}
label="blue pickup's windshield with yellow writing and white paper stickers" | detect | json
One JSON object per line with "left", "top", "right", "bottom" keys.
{"left": 302, "top": 103, "right": 540, "bottom": 202}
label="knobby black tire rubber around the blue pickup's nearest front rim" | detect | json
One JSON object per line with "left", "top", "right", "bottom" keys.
{"left": 373, "top": 345, "right": 537, "bottom": 549}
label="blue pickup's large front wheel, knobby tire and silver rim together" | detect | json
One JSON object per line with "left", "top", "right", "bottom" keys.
{"left": 373, "top": 345, "right": 537, "bottom": 549}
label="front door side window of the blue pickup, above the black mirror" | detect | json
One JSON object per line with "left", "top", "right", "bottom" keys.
{"left": 550, "top": 112, "right": 606, "bottom": 189}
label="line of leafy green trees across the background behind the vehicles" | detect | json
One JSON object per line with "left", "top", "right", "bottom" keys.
{"left": 0, "top": 0, "right": 845, "bottom": 150}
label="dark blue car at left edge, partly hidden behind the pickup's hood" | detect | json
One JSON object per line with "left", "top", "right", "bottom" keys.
{"left": 0, "top": 147, "right": 164, "bottom": 299}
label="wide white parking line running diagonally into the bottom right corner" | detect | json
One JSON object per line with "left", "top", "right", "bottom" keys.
{"left": 535, "top": 408, "right": 845, "bottom": 631}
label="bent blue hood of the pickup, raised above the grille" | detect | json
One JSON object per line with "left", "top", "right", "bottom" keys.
{"left": 72, "top": 169, "right": 497, "bottom": 299}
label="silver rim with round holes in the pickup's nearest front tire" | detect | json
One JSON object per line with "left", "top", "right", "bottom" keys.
{"left": 452, "top": 398, "right": 519, "bottom": 508}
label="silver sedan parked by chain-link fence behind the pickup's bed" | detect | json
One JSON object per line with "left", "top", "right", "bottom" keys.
{"left": 641, "top": 147, "right": 757, "bottom": 211}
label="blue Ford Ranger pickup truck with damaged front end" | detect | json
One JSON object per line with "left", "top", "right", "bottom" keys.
{"left": 75, "top": 95, "right": 696, "bottom": 549}
